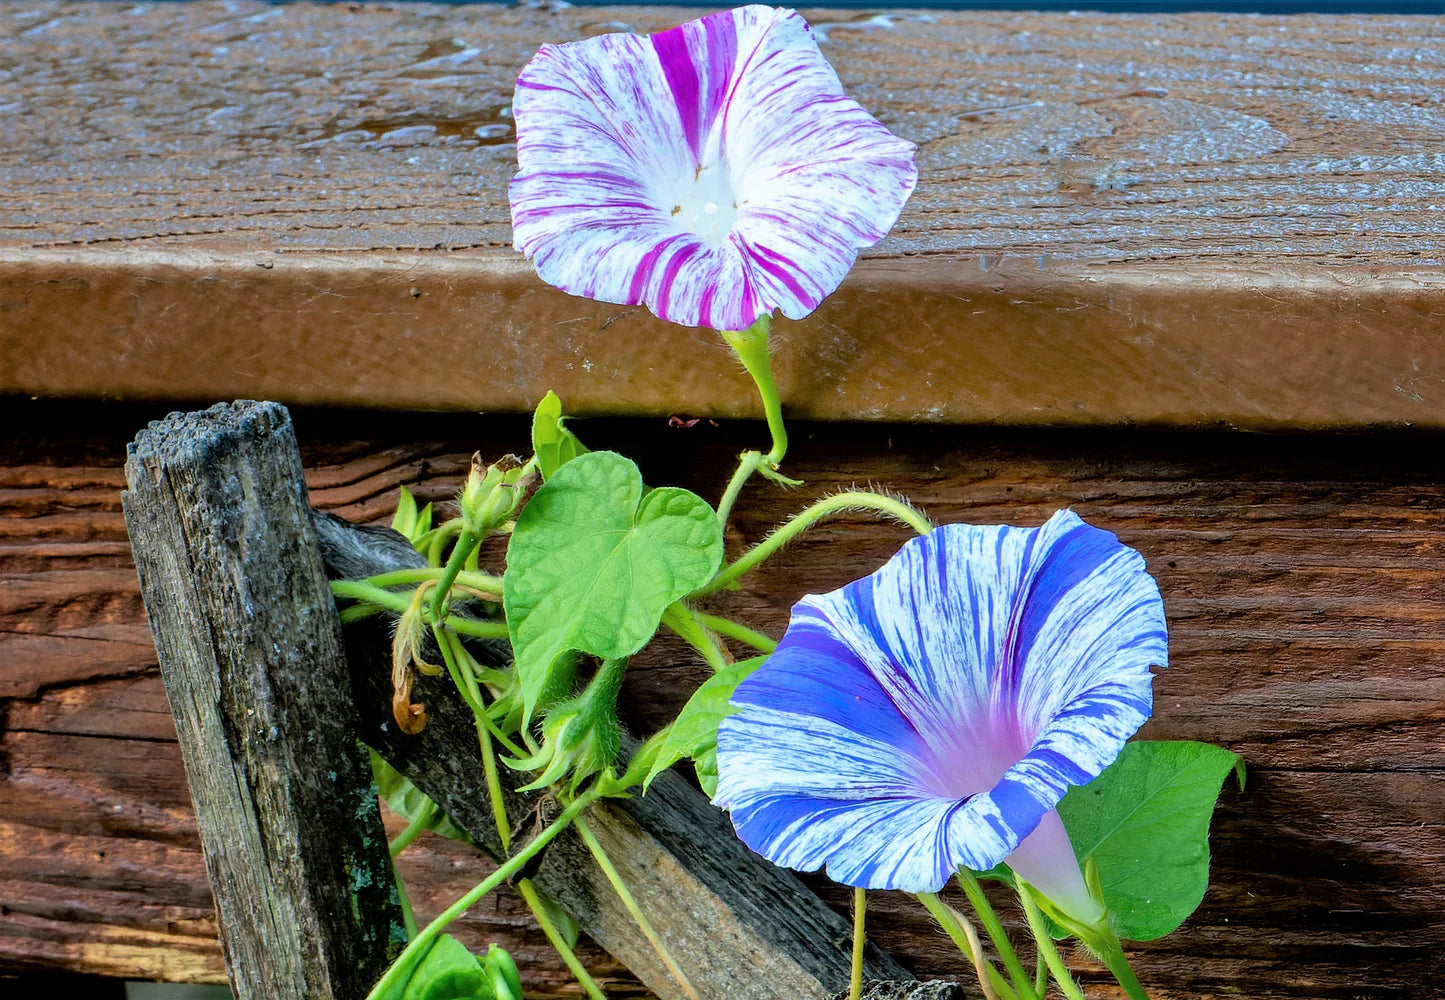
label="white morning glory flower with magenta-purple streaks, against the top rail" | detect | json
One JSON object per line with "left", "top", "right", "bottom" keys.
{"left": 510, "top": 4, "right": 918, "bottom": 331}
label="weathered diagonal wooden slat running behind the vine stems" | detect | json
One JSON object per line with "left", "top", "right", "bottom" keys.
{"left": 316, "top": 514, "right": 910, "bottom": 1000}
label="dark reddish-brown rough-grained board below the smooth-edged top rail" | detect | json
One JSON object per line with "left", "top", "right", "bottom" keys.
{"left": 0, "top": 403, "right": 1445, "bottom": 1000}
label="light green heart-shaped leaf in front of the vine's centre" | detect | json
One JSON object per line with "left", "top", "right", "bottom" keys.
{"left": 503, "top": 451, "right": 723, "bottom": 721}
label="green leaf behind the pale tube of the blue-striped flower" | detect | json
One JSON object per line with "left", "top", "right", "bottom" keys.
{"left": 1059, "top": 740, "right": 1243, "bottom": 941}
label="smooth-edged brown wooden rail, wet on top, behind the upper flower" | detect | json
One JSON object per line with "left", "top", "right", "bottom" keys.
{"left": 0, "top": 0, "right": 1445, "bottom": 428}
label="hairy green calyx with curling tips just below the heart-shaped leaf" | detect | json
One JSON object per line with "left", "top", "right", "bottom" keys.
{"left": 506, "top": 659, "right": 627, "bottom": 793}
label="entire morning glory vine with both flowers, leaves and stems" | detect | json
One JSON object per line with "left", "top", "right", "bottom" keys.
{"left": 334, "top": 6, "right": 1237, "bottom": 1000}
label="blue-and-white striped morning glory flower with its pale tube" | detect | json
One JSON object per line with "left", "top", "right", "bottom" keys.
{"left": 715, "top": 512, "right": 1168, "bottom": 923}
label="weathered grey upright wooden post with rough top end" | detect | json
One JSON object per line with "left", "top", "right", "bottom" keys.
{"left": 123, "top": 403, "right": 406, "bottom": 1000}
